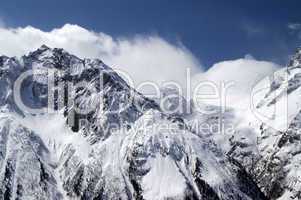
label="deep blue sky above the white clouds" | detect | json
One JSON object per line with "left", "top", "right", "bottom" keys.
{"left": 0, "top": 0, "right": 301, "bottom": 67}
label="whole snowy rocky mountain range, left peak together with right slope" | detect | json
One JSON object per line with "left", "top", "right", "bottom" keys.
{"left": 0, "top": 46, "right": 301, "bottom": 200}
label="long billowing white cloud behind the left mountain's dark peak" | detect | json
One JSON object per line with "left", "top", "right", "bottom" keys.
{"left": 0, "top": 24, "right": 201, "bottom": 90}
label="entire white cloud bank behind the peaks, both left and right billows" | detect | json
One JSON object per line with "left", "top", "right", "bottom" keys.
{"left": 0, "top": 24, "right": 278, "bottom": 105}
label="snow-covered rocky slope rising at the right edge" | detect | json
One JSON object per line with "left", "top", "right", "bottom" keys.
{"left": 228, "top": 49, "right": 301, "bottom": 200}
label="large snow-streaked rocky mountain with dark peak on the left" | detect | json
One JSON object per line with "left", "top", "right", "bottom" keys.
{"left": 0, "top": 46, "right": 270, "bottom": 200}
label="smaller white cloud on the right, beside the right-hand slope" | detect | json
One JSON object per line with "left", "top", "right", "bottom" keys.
{"left": 193, "top": 55, "right": 280, "bottom": 107}
